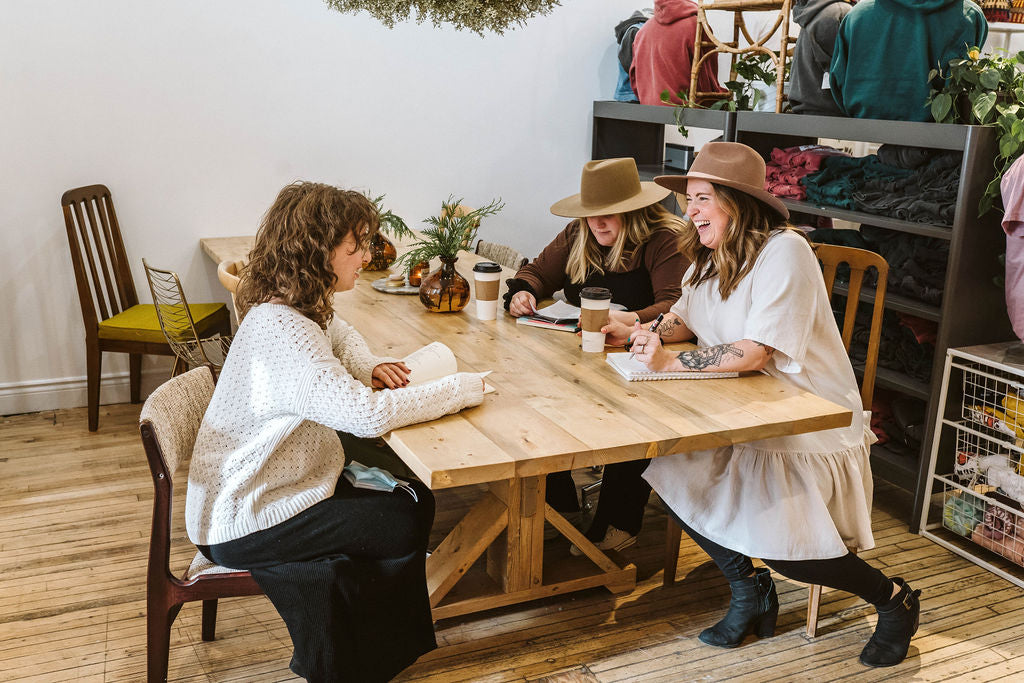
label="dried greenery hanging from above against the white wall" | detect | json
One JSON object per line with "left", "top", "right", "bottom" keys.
{"left": 325, "top": 0, "right": 561, "bottom": 36}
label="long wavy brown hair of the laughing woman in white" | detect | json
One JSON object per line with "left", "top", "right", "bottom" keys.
{"left": 679, "top": 182, "right": 805, "bottom": 299}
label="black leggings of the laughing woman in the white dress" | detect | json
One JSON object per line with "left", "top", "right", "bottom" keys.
{"left": 669, "top": 510, "right": 893, "bottom": 605}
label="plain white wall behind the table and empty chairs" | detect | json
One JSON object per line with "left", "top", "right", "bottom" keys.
{"left": 0, "top": 0, "right": 647, "bottom": 414}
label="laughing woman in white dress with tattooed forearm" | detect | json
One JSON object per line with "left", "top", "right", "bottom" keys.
{"left": 608, "top": 142, "right": 921, "bottom": 667}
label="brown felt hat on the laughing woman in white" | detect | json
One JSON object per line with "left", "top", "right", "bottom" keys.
{"left": 654, "top": 142, "right": 790, "bottom": 218}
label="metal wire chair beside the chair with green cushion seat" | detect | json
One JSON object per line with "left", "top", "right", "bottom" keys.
{"left": 142, "top": 258, "right": 231, "bottom": 377}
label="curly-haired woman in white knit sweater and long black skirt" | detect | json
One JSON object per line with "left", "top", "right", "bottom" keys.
{"left": 185, "top": 182, "right": 483, "bottom": 681}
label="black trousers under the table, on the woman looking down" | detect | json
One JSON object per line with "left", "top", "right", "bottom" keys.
{"left": 545, "top": 460, "right": 650, "bottom": 541}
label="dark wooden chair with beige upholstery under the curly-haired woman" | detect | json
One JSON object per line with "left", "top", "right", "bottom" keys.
{"left": 139, "top": 368, "right": 263, "bottom": 683}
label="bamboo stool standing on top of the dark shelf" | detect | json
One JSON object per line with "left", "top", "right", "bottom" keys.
{"left": 689, "top": 0, "right": 794, "bottom": 113}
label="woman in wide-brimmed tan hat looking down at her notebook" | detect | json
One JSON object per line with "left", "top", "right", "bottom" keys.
{"left": 505, "top": 159, "right": 687, "bottom": 550}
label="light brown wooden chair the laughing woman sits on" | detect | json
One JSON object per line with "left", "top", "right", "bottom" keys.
{"left": 663, "top": 245, "right": 889, "bottom": 638}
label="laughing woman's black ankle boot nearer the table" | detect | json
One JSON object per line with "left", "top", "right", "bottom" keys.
{"left": 698, "top": 567, "right": 778, "bottom": 647}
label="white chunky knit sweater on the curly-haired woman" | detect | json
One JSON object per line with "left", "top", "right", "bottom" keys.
{"left": 185, "top": 303, "right": 483, "bottom": 545}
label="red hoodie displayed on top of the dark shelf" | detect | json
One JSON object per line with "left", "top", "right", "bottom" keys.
{"left": 630, "top": 0, "right": 724, "bottom": 104}
